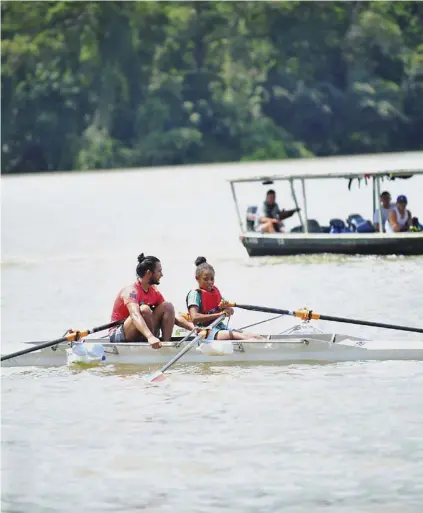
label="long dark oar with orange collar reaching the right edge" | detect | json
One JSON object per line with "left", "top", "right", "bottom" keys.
{"left": 220, "top": 302, "right": 423, "bottom": 333}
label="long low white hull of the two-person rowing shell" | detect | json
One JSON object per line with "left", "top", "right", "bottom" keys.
{"left": 2, "top": 333, "right": 423, "bottom": 367}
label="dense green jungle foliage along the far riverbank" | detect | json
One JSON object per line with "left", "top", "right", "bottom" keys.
{"left": 1, "top": 1, "right": 423, "bottom": 173}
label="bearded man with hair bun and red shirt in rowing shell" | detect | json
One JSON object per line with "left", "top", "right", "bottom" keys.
{"left": 109, "top": 253, "right": 194, "bottom": 349}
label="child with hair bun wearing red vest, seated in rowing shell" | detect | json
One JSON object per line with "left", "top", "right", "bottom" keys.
{"left": 186, "top": 257, "right": 263, "bottom": 340}
